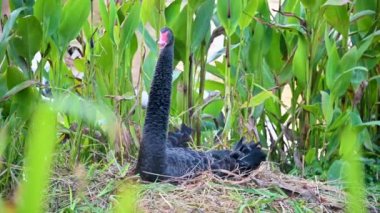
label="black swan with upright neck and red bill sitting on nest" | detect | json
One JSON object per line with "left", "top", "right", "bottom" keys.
{"left": 136, "top": 28, "right": 265, "bottom": 181}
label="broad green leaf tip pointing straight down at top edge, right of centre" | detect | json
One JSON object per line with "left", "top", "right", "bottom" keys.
{"left": 217, "top": 0, "right": 242, "bottom": 36}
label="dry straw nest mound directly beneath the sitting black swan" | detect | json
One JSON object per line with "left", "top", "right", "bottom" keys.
{"left": 139, "top": 162, "right": 345, "bottom": 212}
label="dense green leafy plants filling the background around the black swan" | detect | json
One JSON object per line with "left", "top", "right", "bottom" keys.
{"left": 0, "top": 0, "right": 380, "bottom": 212}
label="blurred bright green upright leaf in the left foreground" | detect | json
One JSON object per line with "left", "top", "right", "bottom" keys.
{"left": 18, "top": 104, "right": 57, "bottom": 212}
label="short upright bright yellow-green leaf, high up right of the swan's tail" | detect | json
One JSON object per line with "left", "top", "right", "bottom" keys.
{"left": 293, "top": 36, "right": 309, "bottom": 87}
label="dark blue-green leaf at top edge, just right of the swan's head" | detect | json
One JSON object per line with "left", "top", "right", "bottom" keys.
{"left": 191, "top": 0, "right": 214, "bottom": 52}
